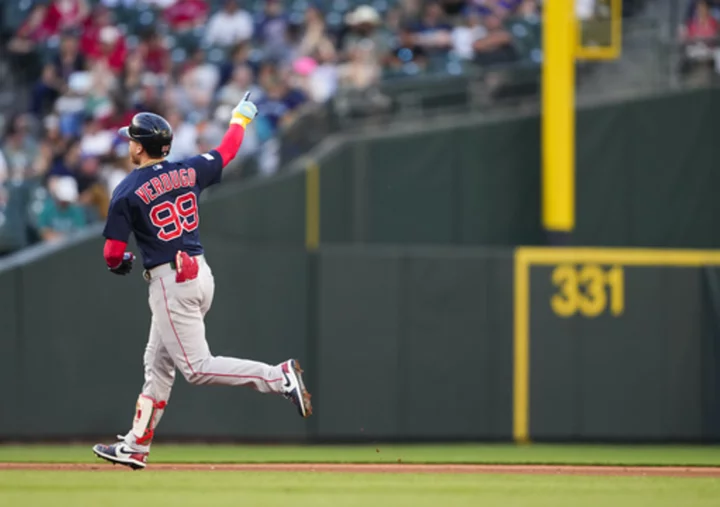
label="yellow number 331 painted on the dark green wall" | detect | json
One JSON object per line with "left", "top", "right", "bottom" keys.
{"left": 550, "top": 264, "right": 625, "bottom": 318}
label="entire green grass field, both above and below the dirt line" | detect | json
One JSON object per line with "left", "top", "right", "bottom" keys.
{"left": 0, "top": 445, "right": 720, "bottom": 507}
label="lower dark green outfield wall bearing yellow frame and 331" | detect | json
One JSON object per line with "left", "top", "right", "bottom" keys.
{"left": 0, "top": 243, "right": 720, "bottom": 441}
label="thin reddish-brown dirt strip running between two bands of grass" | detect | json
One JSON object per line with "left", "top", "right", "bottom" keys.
{"left": 0, "top": 462, "right": 720, "bottom": 478}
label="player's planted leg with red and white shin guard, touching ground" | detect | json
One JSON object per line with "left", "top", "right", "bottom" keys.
{"left": 93, "top": 318, "right": 175, "bottom": 469}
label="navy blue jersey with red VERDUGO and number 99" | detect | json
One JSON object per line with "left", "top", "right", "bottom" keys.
{"left": 103, "top": 150, "right": 223, "bottom": 269}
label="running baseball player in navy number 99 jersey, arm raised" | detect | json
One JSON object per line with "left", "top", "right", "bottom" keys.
{"left": 93, "top": 94, "right": 312, "bottom": 469}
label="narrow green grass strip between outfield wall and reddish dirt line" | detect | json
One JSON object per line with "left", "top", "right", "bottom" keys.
{"left": 0, "top": 444, "right": 720, "bottom": 466}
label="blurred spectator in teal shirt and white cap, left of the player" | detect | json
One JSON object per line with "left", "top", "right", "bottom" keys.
{"left": 37, "top": 176, "right": 87, "bottom": 241}
